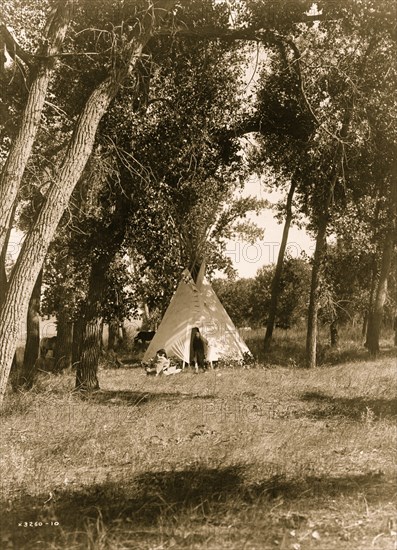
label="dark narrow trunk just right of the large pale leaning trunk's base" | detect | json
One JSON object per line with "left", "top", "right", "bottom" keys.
{"left": 17, "top": 270, "right": 43, "bottom": 390}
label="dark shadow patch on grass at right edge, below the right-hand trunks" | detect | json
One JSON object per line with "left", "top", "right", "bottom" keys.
{"left": 302, "top": 392, "right": 397, "bottom": 421}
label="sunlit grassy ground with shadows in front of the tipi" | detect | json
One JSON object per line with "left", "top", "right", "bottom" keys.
{"left": 0, "top": 334, "right": 397, "bottom": 550}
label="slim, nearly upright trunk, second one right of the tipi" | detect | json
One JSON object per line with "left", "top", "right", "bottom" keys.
{"left": 306, "top": 216, "right": 327, "bottom": 368}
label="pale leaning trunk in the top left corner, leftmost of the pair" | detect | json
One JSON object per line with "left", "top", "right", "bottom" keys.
{"left": 0, "top": 0, "right": 73, "bottom": 254}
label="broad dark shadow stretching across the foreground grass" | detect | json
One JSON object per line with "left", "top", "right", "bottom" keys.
{"left": 0, "top": 466, "right": 394, "bottom": 549}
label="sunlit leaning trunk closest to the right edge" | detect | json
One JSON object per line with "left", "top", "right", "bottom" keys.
{"left": 366, "top": 231, "right": 394, "bottom": 356}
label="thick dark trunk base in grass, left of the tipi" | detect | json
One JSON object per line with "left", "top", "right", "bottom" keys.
{"left": 76, "top": 317, "right": 102, "bottom": 391}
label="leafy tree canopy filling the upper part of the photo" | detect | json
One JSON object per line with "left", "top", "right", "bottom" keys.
{"left": 0, "top": 0, "right": 397, "bottom": 354}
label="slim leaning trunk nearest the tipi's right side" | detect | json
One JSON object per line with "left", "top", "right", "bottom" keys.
{"left": 264, "top": 179, "right": 296, "bottom": 351}
